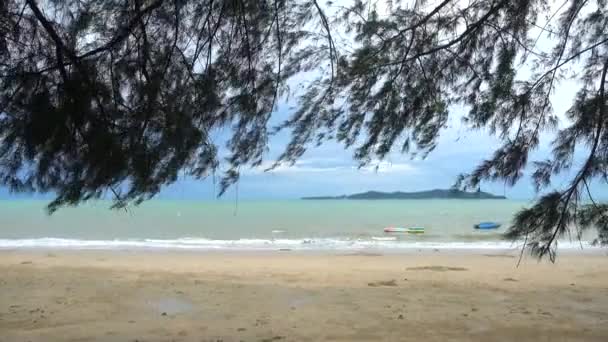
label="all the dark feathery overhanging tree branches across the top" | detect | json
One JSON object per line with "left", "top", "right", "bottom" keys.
{"left": 0, "top": 0, "right": 608, "bottom": 260}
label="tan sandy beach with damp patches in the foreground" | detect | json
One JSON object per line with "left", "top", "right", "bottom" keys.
{"left": 0, "top": 250, "right": 608, "bottom": 342}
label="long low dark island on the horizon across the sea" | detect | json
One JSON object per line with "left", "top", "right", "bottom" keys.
{"left": 302, "top": 189, "right": 506, "bottom": 200}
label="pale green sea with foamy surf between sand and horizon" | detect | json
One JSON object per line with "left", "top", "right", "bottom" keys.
{"left": 0, "top": 200, "right": 592, "bottom": 250}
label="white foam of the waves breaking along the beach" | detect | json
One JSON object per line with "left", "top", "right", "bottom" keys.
{"left": 0, "top": 237, "right": 599, "bottom": 251}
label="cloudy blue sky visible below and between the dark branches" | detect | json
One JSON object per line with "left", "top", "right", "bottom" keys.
{"left": 0, "top": 0, "right": 608, "bottom": 200}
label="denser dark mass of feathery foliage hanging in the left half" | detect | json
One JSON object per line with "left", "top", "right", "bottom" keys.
{"left": 0, "top": 0, "right": 318, "bottom": 211}
